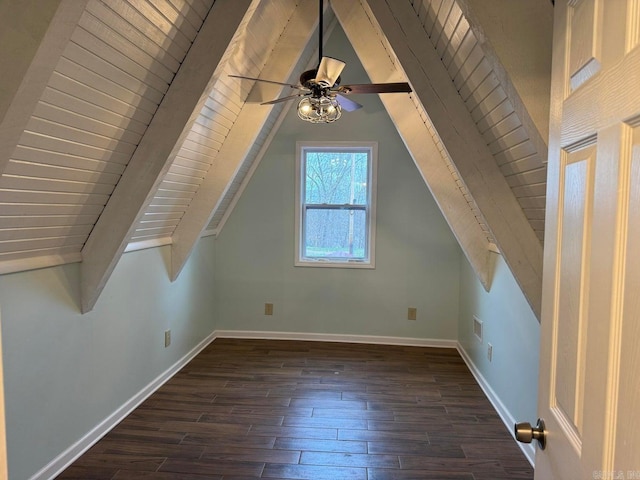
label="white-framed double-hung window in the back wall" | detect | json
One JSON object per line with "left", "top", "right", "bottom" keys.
{"left": 295, "top": 142, "right": 378, "bottom": 268}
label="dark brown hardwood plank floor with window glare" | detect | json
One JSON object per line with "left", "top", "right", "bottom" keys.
{"left": 58, "top": 339, "right": 533, "bottom": 480}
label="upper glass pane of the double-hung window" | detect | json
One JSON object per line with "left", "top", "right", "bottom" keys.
{"left": 305, "top": 150, "right": 368, "bottom": 205}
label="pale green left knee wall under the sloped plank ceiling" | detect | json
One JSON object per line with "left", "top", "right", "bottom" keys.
{"left": 0, "top": 237, "right": 215, "bottom": 480}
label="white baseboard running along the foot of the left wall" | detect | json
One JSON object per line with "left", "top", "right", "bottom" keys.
{"left": 29, "top": 332, "right": 216, "bottom": 480}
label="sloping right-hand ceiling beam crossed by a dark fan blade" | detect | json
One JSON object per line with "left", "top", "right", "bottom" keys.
{"left": 331, "top": 0, "right": 494, "bottom": 290}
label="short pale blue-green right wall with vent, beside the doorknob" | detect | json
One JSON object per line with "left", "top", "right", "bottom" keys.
{"left": 458, "top": 254, "right": 540, "bottom": 430}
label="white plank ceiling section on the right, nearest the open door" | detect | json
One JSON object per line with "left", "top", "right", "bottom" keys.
{"left": 418, "top": 0, "right": 547, "bottom": 248}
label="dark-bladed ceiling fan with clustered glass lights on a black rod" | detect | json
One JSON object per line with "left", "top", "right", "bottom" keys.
{"left": 229, "top": 0, "right": 411, "bottom": 123}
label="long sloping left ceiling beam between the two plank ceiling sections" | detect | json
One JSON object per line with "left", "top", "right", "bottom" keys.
{"left": 81, "top": 0, "right": 257, "bottom": 313}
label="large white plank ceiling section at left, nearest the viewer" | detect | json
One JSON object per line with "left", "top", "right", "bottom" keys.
{"left": 0, "top": 0, "right": 212, "bottom": 276}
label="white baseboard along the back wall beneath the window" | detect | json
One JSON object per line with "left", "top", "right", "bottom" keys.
{"left": 215, "top": 330, "right": 458, "bottom": 348}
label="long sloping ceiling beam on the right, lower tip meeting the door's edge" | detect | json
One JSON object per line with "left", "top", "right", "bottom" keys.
{"left": 367, "top": 0, "right": 542, "bottom": 318}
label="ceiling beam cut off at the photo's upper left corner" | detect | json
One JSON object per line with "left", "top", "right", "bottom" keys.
{"left": 0, "top": 0, "right": 87, "bottom": 174}
